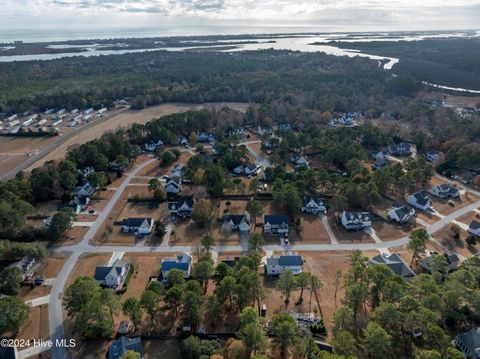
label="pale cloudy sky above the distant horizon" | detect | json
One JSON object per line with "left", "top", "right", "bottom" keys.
{"left": 0, "top": 0, "right": 480, "bottom": 35}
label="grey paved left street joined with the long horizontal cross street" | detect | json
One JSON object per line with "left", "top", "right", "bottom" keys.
{"left": 48, "top": 159, "right": 480, "bottom": 359}
